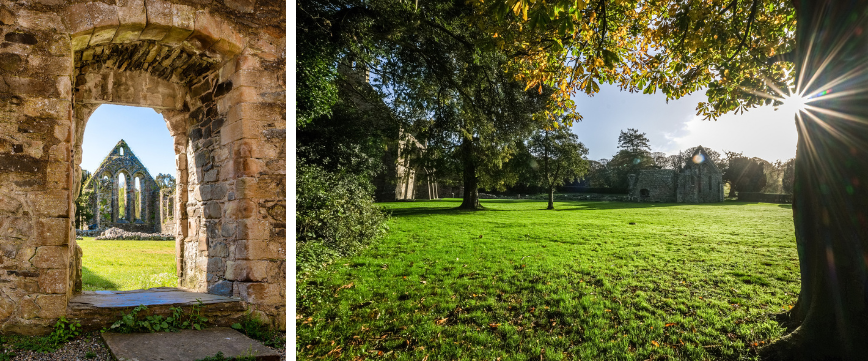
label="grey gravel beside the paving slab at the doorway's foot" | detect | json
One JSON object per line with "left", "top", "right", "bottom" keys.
{"left": 5, "top": 331, "right": 286, "bottom": 361}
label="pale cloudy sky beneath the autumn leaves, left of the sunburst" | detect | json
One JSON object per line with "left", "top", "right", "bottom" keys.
{"left": 572, "top": 85, "right": 797, "bottom": 162}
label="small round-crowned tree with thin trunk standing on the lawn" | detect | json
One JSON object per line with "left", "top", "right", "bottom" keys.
{"left": 528, "top": 128, "right": 588, "bottom": 209}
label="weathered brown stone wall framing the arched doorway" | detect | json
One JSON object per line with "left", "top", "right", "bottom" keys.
{"left": 0, "top": 0, "right": 286, "bottom": 334}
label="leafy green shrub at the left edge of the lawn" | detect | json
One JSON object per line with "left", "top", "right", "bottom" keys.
{"left": 295, "top": 163, "right": 387, "bottom": 274}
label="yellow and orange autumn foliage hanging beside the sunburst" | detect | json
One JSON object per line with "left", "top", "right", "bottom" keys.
{"left": 475, "top": 0, "right": 795, "bottom": 125}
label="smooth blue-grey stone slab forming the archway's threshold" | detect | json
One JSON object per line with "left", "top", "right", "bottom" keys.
{"left": 69, "top": 287, "right": 241, "bottom": 309}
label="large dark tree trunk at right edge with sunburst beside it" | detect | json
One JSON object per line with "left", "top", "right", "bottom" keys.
{"left": 761, "top": 0, "right": 868, "bottom": 360}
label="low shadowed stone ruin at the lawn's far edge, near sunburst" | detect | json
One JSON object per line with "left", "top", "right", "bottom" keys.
{"left": 627, "top": 146, "right": 723, "bottom": 203}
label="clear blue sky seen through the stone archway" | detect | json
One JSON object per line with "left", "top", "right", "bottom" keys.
{"left": 81, "top": 104, "right": 175, "bottom": 178}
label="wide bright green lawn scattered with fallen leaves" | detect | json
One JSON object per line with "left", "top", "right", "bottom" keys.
{"left": 296, "top": 200, "right": 799, "bottom": 360}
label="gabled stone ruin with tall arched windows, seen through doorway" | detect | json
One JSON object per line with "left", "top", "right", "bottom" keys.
{"left": 83, "top": 139, "right": 163, "bottom": 233}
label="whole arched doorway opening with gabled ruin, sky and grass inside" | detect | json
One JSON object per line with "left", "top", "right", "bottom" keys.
{"left": 75, "top": 104, "right": 179, "bottom": 291}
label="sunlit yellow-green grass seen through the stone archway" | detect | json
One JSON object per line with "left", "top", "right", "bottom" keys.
{"left": 78, "top": 237, "right": 178, "bottom": 291}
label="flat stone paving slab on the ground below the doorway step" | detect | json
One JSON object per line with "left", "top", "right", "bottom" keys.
{"left": 102, "top": 327, "right": 280, "bottom": 361}
